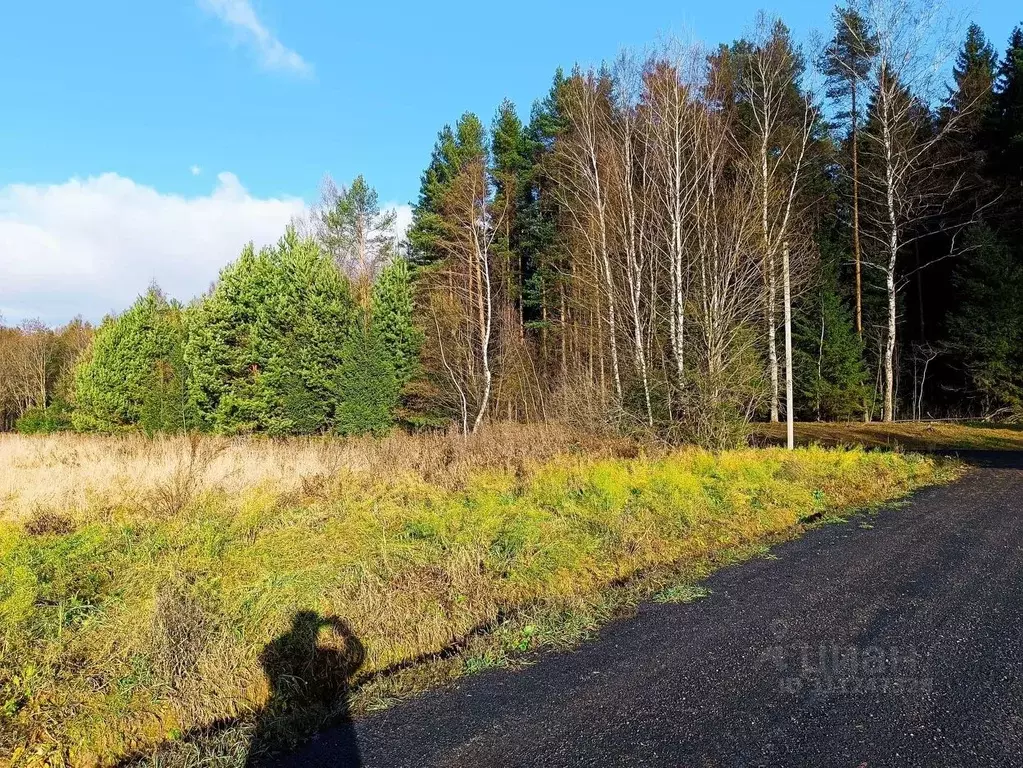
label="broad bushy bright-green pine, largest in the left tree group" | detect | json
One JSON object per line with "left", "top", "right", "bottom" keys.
{"left": 185, "top": 228, "right": 358, "bottom": 435}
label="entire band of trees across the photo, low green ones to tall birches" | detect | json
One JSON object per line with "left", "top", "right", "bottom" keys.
{"left": 0, "top": 2, "right": 1023, "bottom": 447}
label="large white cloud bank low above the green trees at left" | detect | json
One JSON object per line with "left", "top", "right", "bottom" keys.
{"left": 0, "top": 173, "right": 305, "bottom": 323}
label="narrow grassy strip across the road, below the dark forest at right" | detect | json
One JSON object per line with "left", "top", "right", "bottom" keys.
{"left": 754, "top": 421, "right": 1023, "bottom": 451}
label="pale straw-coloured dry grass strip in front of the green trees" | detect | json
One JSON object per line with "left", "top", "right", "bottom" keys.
{"left": 0, "top": 425, "right": 635, "bottom": 519}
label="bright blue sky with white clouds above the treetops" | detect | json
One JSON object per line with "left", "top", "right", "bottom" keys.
{"left": 0, "top": 0, "right": 1023, "bottom": 322}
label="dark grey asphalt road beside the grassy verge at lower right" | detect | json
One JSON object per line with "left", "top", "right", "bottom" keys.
{"left": 283, "top": 454, "right": 1023, "bottom": 768}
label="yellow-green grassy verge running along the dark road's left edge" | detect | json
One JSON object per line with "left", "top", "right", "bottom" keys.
{"left": 0, "top": 435, "right": 952, "bottom": 765}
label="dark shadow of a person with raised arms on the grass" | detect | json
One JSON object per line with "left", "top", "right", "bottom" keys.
{"left": 246, "top": 611, "right": 365, "bottom": 768}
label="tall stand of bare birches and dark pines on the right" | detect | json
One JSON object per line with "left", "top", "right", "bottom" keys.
{"left": 409, "top": 0, "right": 1023, "bottom": 443}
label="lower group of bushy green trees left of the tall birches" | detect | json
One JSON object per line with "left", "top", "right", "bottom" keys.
{"left": 0, "top": 177, "right": 420, "bottom": 436}
